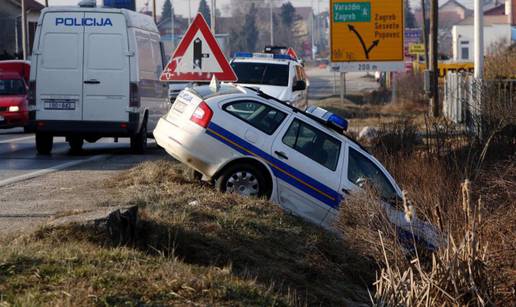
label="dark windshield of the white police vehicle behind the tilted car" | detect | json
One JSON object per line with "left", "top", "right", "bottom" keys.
{"left": 231, "top": 62, "right": 289, "bottom": 86}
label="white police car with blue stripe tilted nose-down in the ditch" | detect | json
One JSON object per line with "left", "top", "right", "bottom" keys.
{"left": 154, "top": 84, "right": 437, "bottom": 250}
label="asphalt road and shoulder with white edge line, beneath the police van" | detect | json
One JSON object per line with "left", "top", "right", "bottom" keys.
{"left": 0, "top": 129, "right": 168, "bottom": 238}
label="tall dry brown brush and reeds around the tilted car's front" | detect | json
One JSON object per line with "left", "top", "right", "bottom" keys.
{"left": 338, "top": 115, "right": 516, "bottom": 306}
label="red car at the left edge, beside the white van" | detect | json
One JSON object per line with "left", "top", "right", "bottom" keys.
{"left": 0, "top": 61, "right": 30, "bottom": 128}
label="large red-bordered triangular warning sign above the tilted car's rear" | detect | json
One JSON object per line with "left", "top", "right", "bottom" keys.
{"left": 160, "top": 14, "right": 237, "bottom": 82}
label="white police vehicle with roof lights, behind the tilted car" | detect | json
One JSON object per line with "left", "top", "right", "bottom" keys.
{"left": 231, "top": 52, "right": 309, "bottom": 109}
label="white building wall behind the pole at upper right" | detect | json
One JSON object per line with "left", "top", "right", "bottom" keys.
{"left": 452, "top": 24, "right": 511, "bottom": 61}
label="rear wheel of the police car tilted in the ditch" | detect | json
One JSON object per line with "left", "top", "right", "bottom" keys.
{"left": 215, "top": 163, "right": 271, "bottom": 198}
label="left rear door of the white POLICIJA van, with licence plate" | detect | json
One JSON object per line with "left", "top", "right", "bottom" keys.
{"left": 34, "top": 12, "right": 84, "bottom": 120}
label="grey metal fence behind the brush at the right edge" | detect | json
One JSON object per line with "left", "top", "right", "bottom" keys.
{"left": 443, "top": 73, "right": 516, "bottom": 136}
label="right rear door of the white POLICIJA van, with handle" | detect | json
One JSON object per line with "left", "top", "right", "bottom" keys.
{"left": 83, "top": 13, "right": 129, "bottom": 122}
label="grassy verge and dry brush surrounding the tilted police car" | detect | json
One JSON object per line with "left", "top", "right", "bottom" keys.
{"left": 0, "top": 50, "right": 516, "bottom": 306}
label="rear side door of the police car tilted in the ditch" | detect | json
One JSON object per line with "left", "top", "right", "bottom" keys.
{"left": 271, "top": 116, "right": 342, "bottom": 224}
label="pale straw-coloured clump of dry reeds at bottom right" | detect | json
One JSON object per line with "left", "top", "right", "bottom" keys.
{"left": 374, "top": 181, "right": 495, "bottom": 306}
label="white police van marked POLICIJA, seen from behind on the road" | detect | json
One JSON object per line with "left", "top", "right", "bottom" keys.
{"left": 29, "top": 6, "right": 170, "bottom": 154}
